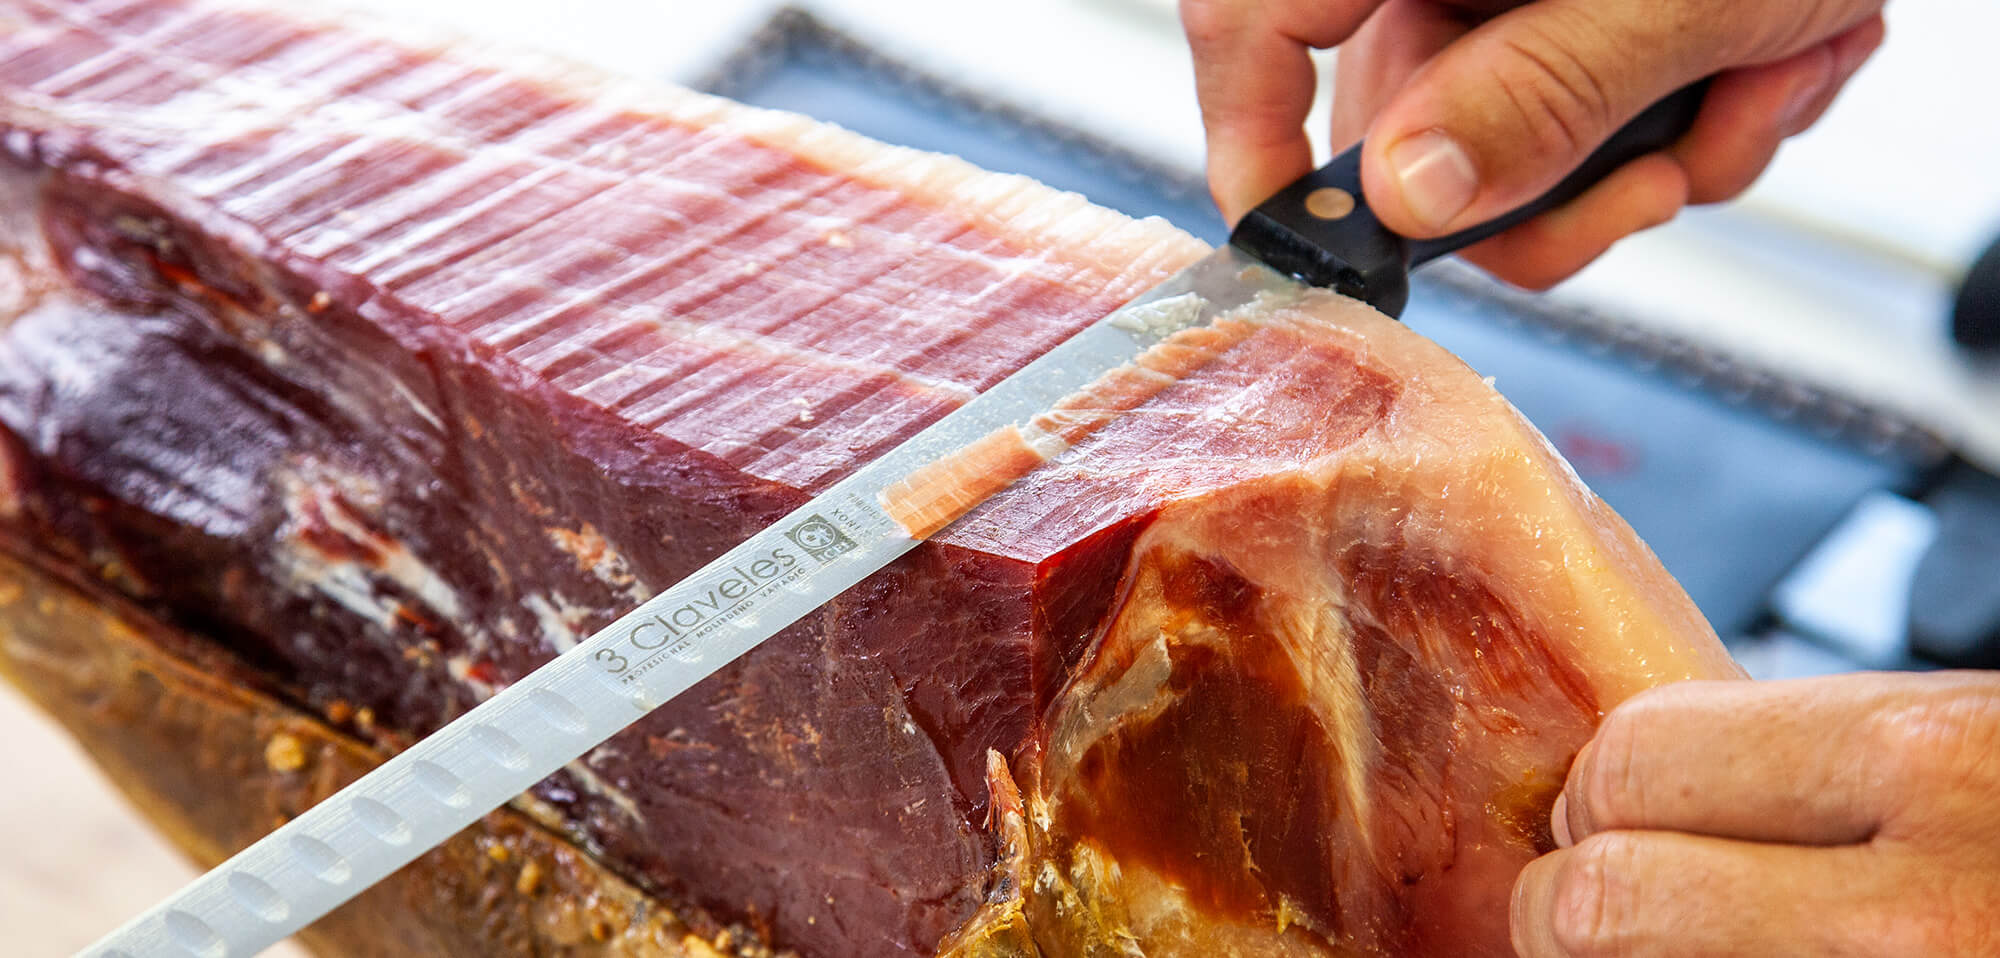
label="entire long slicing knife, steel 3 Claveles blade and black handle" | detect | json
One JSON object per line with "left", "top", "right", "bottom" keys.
{"left": 78, "top": 84, "right": 1704, "bottom": 958}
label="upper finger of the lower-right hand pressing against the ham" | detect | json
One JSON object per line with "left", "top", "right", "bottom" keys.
{"left": 1554, "top": 674, "right": 1924, "bottom": 844}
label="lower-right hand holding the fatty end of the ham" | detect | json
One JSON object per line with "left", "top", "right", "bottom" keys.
{"left": 1512, "top": 672, "right": 2000, "bottom": 958}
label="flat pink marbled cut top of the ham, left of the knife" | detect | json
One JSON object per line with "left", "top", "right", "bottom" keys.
{"left": 0, "top": 0, "right": 1198, "bottom": 502}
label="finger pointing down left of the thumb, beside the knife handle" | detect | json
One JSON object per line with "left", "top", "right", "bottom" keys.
{"left": 1180, "top": 0, "right": 1380, "bottom": 224}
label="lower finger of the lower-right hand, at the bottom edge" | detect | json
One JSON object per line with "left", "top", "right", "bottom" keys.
{"left": 1508, "top": 832, "right": 1888, "bottom": 958}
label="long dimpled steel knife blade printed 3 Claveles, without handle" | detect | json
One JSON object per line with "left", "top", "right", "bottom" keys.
{"left": 80, "top": 246, "right": 1300, "bottom": 958}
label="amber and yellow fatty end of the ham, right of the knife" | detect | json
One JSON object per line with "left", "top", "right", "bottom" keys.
{"left": 1008, "top": 296, "right": 1740, "bottom": 956}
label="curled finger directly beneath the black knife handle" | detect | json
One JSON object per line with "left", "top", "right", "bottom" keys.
{"left": 1460, "top": 154, "right": 1688, "bottom": 290}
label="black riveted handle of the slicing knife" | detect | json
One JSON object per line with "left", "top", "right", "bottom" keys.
{"left": 1230, "top": 80, "right": 1708, "bottom": 316}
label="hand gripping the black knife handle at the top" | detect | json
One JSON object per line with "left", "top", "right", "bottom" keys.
{"left": 1180, "top": 0, "right": 1882, "bottom": 288}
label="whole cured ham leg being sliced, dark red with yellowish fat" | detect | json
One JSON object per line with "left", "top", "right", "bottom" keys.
{"left": 0, "top": 0, "right": 1736, "bottom": 956}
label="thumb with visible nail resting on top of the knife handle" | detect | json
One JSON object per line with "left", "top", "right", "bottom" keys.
{"left": 1362, "top": 0, "right": 1846, "bottom": 236}
